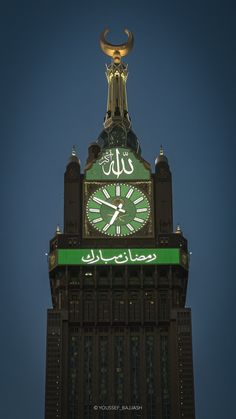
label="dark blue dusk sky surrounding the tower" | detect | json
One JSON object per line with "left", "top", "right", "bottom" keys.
{"left": 0, "top": 0, "right": 236, "bottom": 419}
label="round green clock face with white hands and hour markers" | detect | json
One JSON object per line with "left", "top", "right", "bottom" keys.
{"left": 86, "top": 183, "right": 150, "bottom": 237}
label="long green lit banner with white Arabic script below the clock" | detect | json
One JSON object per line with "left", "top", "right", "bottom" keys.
{"left": 49, "top": 248, "right": 188, "bottom": 269}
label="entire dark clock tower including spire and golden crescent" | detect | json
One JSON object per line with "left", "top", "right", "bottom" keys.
{"left": 45, "top": 31, "right": 195, "bottom": 419}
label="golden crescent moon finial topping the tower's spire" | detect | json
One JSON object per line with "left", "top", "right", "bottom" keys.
{"left": 100, "top": 29, "right": 134, "bottom": 63}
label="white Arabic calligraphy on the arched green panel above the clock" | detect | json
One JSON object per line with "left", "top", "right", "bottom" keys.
{"left": 99, "top": 148, "right": 134, "bottom": 179}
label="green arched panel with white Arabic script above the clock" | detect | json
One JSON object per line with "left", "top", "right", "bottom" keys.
{"left": 85, "top": 147, "right": 151, "bottom": 181}
